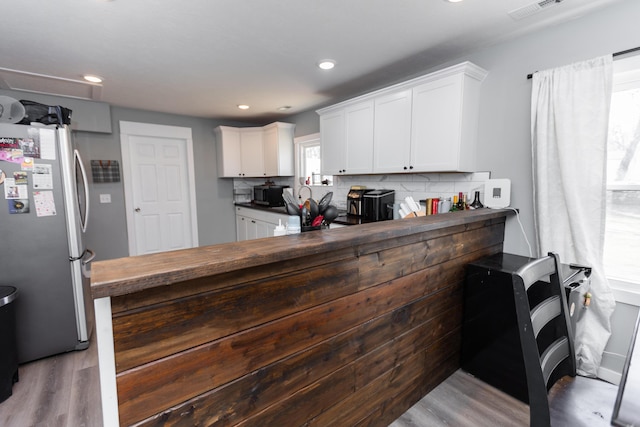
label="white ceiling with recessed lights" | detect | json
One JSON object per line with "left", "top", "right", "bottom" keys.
{"left": 0, "top": 0, "right": 620, "bottom": 123}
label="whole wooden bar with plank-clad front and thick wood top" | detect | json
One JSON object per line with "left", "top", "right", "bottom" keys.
{"left": 91, "top": 209, "right": 511, "bottom": 427}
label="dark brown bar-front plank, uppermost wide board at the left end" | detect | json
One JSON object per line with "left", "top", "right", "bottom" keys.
{"left": 113, "top": 258, "right": 359, "bottom": 372}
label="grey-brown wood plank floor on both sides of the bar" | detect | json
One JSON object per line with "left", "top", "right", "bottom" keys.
{"left": 0, "top": 343, "right": 617, "bottom": 427}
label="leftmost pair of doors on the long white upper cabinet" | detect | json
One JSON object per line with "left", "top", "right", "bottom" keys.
{"left": 320, "top": 101, "right": 374, "bottom": 175}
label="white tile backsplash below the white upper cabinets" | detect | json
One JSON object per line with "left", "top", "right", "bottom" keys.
{"left": 233, "top": 172, "right": 491, "bottom": 209}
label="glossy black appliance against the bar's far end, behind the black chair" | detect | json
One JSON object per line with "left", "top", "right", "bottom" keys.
{"left": 460, "top": 253, "right": 591, "bottom": 403}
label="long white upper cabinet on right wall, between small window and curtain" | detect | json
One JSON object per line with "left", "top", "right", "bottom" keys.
{"left": 318, "top": 62, "right": 487, "bottom": 175}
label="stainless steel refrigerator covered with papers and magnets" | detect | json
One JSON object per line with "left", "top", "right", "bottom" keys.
{"left": 0, "top": 124, "right": 94, "bottom": 363}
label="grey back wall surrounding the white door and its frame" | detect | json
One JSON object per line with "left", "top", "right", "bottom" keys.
{"left": 75, "top": 107, "right": 251, "bottom": 260}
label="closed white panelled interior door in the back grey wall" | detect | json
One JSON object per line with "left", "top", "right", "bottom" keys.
{"left": 120, "top": 122, "right": 198, "bottom": 255}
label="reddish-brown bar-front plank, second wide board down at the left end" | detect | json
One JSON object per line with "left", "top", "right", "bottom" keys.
{"left": 117, "top": 274, "right": 440, "bottom": 424}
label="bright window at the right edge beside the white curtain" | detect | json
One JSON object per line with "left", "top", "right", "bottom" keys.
{"left": 604, "top": 56, "right": 640, "bottom": 292}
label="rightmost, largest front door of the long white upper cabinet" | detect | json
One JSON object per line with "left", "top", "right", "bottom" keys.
{"left": 411, "top": 74, "right": 464, "bottom": 172}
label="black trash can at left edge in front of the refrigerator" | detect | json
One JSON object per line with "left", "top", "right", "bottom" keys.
{"left": 0, "top": 286, "right": 18, "bottom": 402}
